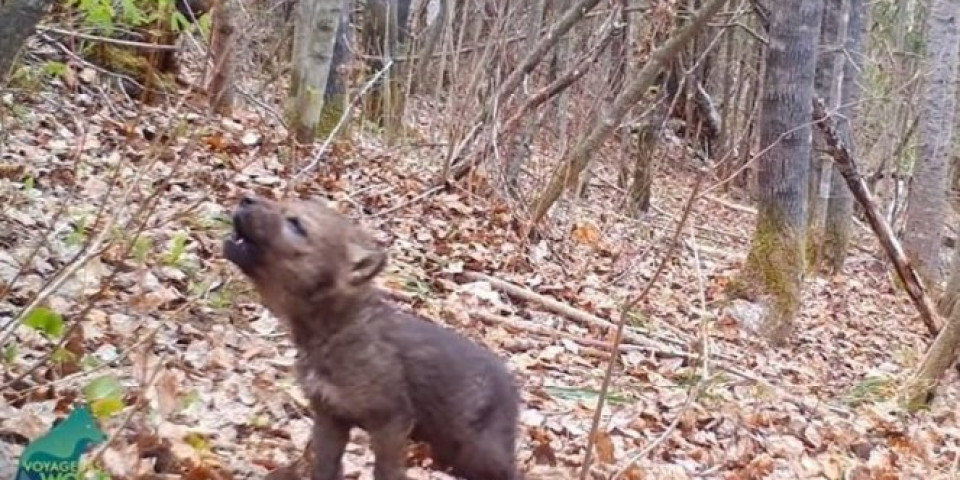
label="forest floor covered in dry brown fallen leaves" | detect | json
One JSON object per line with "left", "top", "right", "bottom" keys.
{"left": 0, "top": 64, "right": 960, "bottom": 479}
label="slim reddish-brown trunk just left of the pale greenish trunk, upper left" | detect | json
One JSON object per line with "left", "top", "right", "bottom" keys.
{"left": 207, "top": 0, "right": 236, "bottom": 115}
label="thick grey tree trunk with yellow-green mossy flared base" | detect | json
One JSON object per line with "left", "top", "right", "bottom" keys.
{"left": 732, "top": 0, "right": 823, "bottom": 345}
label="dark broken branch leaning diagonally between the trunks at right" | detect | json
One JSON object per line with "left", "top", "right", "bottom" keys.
{"left": 813, "top": 98, "right": 943, "bottom": 335}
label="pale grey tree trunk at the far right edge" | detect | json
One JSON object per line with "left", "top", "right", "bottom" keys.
{"left": 903, "top": 0, "right": 960, "bottom": 290}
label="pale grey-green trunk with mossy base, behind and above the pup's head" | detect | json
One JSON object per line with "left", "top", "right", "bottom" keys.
{"left": 289, "top": 0, "right": 342, "bottom": 143}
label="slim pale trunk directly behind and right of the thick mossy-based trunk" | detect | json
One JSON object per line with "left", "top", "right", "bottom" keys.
{"left": 807, "top": 0, "right": 844, "bottom": 269}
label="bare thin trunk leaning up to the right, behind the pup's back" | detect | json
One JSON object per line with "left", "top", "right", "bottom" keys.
{"left": 531, "top": 0, "right": 726, "bottom": 223}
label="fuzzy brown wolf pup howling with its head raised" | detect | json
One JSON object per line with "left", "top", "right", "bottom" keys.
{"left": 223, "top": 197, "right": 522, "bottom": 480}
